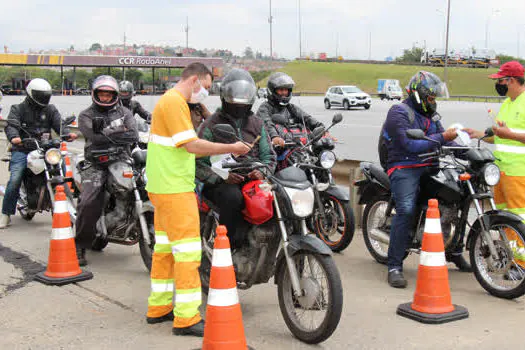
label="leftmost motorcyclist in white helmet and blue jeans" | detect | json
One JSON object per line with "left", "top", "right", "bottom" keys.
{"left": 0, "top": 78, "right": 77, "bottom": 228}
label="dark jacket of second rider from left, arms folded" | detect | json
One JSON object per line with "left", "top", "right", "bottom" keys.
{"left": 78, "top": 103, "right": 139, "bottom": 159}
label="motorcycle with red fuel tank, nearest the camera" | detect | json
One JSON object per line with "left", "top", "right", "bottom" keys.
{"left": 200, "top": 124, "right": 343, "bottom": 344}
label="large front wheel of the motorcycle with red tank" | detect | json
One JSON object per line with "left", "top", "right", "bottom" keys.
{"left": 276, "top": 251, "right": 343, "bottom": 344}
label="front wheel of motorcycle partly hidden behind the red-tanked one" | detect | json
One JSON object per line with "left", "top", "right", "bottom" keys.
{"left": 314, "top": 196, "right": 355, "bottom": 252}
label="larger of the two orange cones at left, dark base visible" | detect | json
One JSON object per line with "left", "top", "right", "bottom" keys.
{"left": 35, "top": 186, "right": 93, "bottom": 286}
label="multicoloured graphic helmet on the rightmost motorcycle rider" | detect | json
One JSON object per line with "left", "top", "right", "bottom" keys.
{"left": 406, "top": 71, "right": 449, "bottom": 117}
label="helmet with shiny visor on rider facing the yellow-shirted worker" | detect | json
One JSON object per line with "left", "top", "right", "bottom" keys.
{"left": 220, "top": 68, "right": 256, "bottom": 118}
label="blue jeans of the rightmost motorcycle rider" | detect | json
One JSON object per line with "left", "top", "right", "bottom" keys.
{"left": 388, "top": 167, "right": 427, "bottom": 271}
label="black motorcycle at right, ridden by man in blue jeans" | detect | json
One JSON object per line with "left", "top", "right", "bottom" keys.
{"left": 356, "top": 130, "right": 525, "bottom": 299}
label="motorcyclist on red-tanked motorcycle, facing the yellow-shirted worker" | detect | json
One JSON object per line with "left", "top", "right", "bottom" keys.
{"left": 196, "top": 69, "right": 275, "bottom": 249}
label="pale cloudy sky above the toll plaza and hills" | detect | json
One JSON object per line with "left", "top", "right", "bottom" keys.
{"left": 0, "top": 0, "right": 525, "bottom": 60}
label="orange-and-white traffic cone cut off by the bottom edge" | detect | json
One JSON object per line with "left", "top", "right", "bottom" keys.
{"left": 202, "top": 226, "right": 252, "bottom": 350}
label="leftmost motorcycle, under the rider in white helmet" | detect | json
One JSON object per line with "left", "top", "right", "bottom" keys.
{"left": 2, "top": 116, "right": 78, "bottom": 224}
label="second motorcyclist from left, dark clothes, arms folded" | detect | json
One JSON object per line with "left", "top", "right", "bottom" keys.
{"left": 75, "top": 75, "right": 138, "bottom": 266}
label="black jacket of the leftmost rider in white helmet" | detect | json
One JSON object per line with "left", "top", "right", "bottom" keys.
{"left": 5, "top": 97, "right": 69, "bottom": 153}
